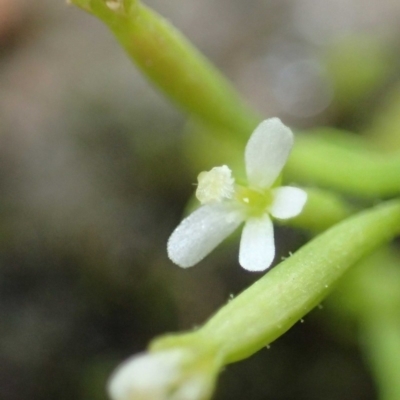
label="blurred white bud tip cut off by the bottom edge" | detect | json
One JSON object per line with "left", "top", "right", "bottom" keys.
{"left": 108, "top": 349, "right": 216, "bottom": 400}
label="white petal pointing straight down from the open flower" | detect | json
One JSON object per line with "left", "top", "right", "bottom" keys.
{"left": 239, "top": 214, "right": 275, "bottom": 271}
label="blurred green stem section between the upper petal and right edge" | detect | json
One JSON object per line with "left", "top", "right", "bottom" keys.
{"left": 285, "top": 135, "right": 400, "bottom": 198}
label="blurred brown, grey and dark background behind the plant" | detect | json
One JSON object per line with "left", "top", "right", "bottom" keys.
{"left": 0, "top": 0, "right": 400, "bottom": 400}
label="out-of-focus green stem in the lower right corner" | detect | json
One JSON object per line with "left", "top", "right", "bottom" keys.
{"left": 333, "top": 246, "right": 400, "bottom": 400}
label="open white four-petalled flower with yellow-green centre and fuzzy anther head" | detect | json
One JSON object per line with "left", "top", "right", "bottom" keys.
{"left": 167, "top": 118, "right": 307, "bottom": 271}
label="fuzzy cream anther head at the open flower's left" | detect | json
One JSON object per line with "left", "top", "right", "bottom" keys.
{"left": 196, "top": 165, "right": 235, "bottom": 204}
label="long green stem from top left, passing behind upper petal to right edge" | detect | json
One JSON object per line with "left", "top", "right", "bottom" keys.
{"left": 72, "top": 0, "right": 400, "bottom": 197}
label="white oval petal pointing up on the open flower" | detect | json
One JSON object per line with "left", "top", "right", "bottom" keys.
{"left": 244, "top": 118, "right": 293, "bottom": 188}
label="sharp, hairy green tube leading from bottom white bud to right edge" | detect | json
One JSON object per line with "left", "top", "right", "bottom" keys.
{"left": 152, "top": 200, "right": 400, "bottom": 364}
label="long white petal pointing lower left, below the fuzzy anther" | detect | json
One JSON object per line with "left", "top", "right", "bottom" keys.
{"left": 167, "top": 203, "right": 244, "bottom": 268}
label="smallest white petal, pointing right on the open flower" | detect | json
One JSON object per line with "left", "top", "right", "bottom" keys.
{"left": 269, "top": 186, "right": 307, "bottom": 219}
